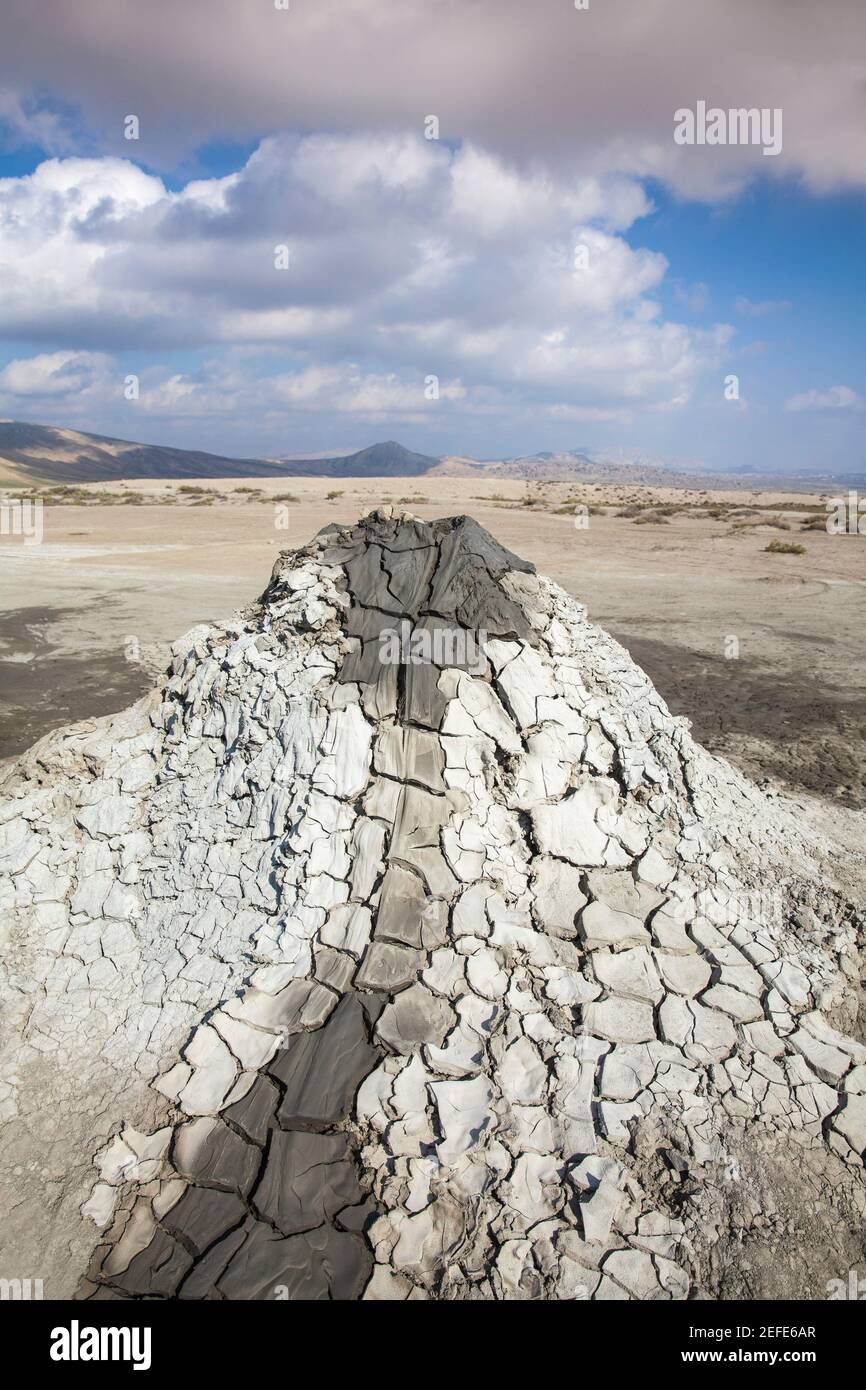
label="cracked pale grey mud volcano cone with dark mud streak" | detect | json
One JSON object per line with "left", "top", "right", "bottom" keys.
{"left": 0, "top": 512, "right": 866, "bottom": 1300}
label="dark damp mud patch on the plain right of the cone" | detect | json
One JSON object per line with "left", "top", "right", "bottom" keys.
{"left": 612, "top": 630, "right": 866, "bottom": 809}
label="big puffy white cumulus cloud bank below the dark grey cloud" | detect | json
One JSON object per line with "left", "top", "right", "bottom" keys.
{"left": 0, "top": 133, "right": 733, "bottom": 418}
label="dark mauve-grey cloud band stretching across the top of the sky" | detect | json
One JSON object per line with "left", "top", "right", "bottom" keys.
{"left": 0, "top": 0, "right": 866, "bottom": 198}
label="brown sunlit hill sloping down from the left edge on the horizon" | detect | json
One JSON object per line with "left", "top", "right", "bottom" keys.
{"left": 0, "top": 420, "right": 282, "bottom": 482}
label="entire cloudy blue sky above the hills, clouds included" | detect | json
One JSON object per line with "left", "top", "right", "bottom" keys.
{"left": 0, "top": 0, "right": 866, "bottom": 473}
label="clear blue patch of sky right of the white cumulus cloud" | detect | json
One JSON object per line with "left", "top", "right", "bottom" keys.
{"left": 614, "top": 179, "right": 866, "bottom": 471}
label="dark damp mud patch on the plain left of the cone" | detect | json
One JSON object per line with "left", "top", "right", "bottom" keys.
{"left": 0, "top": 600, "right": 153, "bottom": 759}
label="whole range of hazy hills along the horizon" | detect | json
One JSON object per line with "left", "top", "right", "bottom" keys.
{"left": 0, "top": 420, "right": 865, "bottom": 491}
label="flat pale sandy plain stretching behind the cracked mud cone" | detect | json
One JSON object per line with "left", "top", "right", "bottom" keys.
{"left": 0, "top": 477, "right": 866, "bottom": 806}
